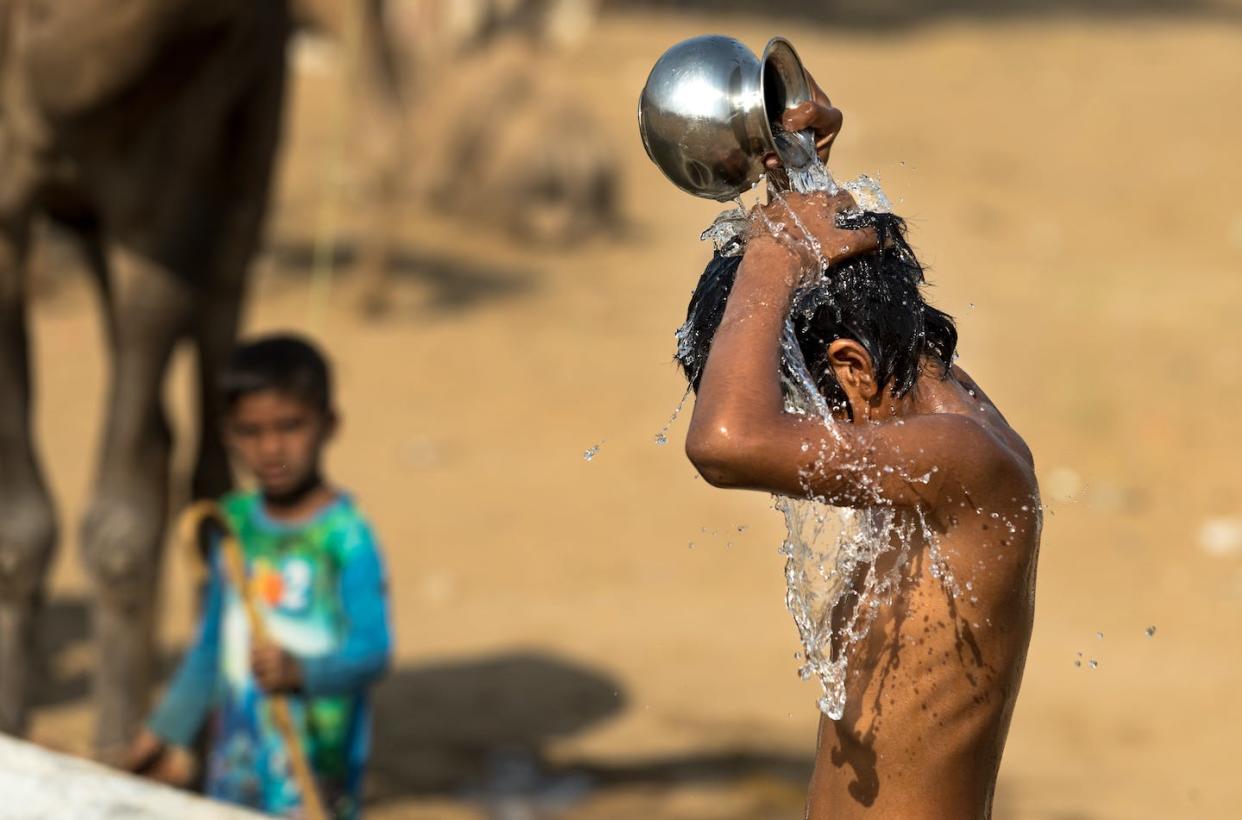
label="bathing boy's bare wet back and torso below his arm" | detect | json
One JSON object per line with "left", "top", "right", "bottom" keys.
{"left": 807, "top": 369, "right": 1041, "bottom": 820}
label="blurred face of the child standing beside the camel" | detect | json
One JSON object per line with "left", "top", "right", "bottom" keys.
{"left": 225, "top": 390, "right": 335, "bottom": 496}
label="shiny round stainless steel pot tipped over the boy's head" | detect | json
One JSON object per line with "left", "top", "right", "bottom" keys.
{"left": 638, "top": 35, "right": 811, "bottom": 200}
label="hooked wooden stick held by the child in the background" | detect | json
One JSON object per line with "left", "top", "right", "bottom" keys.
{"left": 178, "top": 501, "right": 328, "bottom": 820}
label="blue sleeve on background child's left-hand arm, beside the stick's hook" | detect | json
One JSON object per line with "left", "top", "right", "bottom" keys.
{"left": 147, "top": 559, "right": 224, "bottom": 745}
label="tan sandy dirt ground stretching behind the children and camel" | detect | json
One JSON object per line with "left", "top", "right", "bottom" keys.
{"left": 19, "top": 7, "right": 1242, "bottom": 820}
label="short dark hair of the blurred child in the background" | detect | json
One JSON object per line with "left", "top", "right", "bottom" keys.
{"left": 219, "top": 333, "right": 332, "bottom": 412}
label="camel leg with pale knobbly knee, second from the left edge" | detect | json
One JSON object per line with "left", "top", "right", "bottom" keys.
{"left": 81, "top": 244, "right": 194, "bottom": 755}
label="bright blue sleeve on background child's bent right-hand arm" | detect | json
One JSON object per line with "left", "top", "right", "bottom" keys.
{"left": 299, "top": 528, "right": 392, "bottom": 697}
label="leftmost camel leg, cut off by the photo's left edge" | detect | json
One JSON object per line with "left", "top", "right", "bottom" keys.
{"left": 0, "top": 212, "right": 56, "bottom": 734}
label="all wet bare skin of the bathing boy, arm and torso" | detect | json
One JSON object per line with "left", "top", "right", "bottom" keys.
{"left": 686, "top": 132, "right": 1041, "bottom": 820}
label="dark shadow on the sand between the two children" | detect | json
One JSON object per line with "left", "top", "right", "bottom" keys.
{"left": 368, "top": 654, "right": 812, "bottom": 814}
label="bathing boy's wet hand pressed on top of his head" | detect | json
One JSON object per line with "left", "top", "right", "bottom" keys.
{"left": 750, "top": 191, "right": 879, "bottom": 267}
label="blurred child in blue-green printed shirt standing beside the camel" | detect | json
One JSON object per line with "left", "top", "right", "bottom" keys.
{"left": 128, "top": 335, "right": 390, "bottom": 818}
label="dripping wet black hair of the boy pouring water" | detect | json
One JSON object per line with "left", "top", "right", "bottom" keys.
{"left": 677, "top": 211, "right": 958, "bottom": 414}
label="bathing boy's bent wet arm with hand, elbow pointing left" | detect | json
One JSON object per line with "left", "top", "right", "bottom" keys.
{"left": 686, "top": 194, "right": 1013, "bottom": 506}
